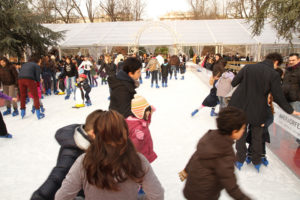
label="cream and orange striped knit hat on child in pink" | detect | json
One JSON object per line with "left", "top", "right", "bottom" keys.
{"left": 131, "top": 95, "right": 150, "bottom": 119}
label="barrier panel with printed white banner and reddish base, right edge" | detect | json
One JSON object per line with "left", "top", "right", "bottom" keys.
{"left": 268, "top": 104, "right": 300, "bottom": 178}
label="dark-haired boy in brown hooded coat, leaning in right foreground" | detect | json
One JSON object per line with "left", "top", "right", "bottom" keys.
{"left": 179, "top": 107, "right": 250, "bottom": 200}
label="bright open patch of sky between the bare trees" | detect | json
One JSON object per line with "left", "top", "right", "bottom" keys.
{"left": 144, "top": 0, "right": 190, "bottom": 19}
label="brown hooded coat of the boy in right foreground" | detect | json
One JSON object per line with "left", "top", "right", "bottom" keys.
{"left": 183, "top": 130, "right": 249, "bottom": 200}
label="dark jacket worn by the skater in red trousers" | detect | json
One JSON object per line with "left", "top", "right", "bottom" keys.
{"left": 19, "top": 62, "right": 41, "bottom": 82}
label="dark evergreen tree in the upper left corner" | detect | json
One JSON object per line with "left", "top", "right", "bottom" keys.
{"left": 0, "top": 0, "right": 62, "bottom": 58}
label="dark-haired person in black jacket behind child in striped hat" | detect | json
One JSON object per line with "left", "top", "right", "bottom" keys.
{"left": 108, "top": 57, "right": 142, "bottom": 118}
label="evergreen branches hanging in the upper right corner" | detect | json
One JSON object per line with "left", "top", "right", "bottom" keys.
{"left": 249, "top": 0, "right": 300, "bottom": 41}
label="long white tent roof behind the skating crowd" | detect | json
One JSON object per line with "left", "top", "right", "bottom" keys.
{"left": 44, "top": 19, "right": 300, "bottom": 48}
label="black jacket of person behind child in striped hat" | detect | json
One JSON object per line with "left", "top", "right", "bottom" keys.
{"left": 108, "top": 70, "right": 136, "bottom": 118}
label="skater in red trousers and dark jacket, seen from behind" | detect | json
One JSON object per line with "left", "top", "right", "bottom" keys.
{"left": 18, "top": 56, "right": 45, "bottom": 119}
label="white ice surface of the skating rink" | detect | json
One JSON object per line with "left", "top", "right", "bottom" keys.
{"left": 0, "top": 66, "right": 300, "bottom": 200}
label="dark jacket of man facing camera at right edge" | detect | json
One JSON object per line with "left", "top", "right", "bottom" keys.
{"left": 282, "top": 62, "right": 300, "bottom": 102}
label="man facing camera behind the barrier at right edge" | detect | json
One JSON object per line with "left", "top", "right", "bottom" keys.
{"left": 282, "top": 53, "right": 300, "bottom": 112}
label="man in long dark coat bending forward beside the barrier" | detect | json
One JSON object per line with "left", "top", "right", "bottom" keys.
{"left": 229, "top": 53, "right": 300, "bottom": 171}
